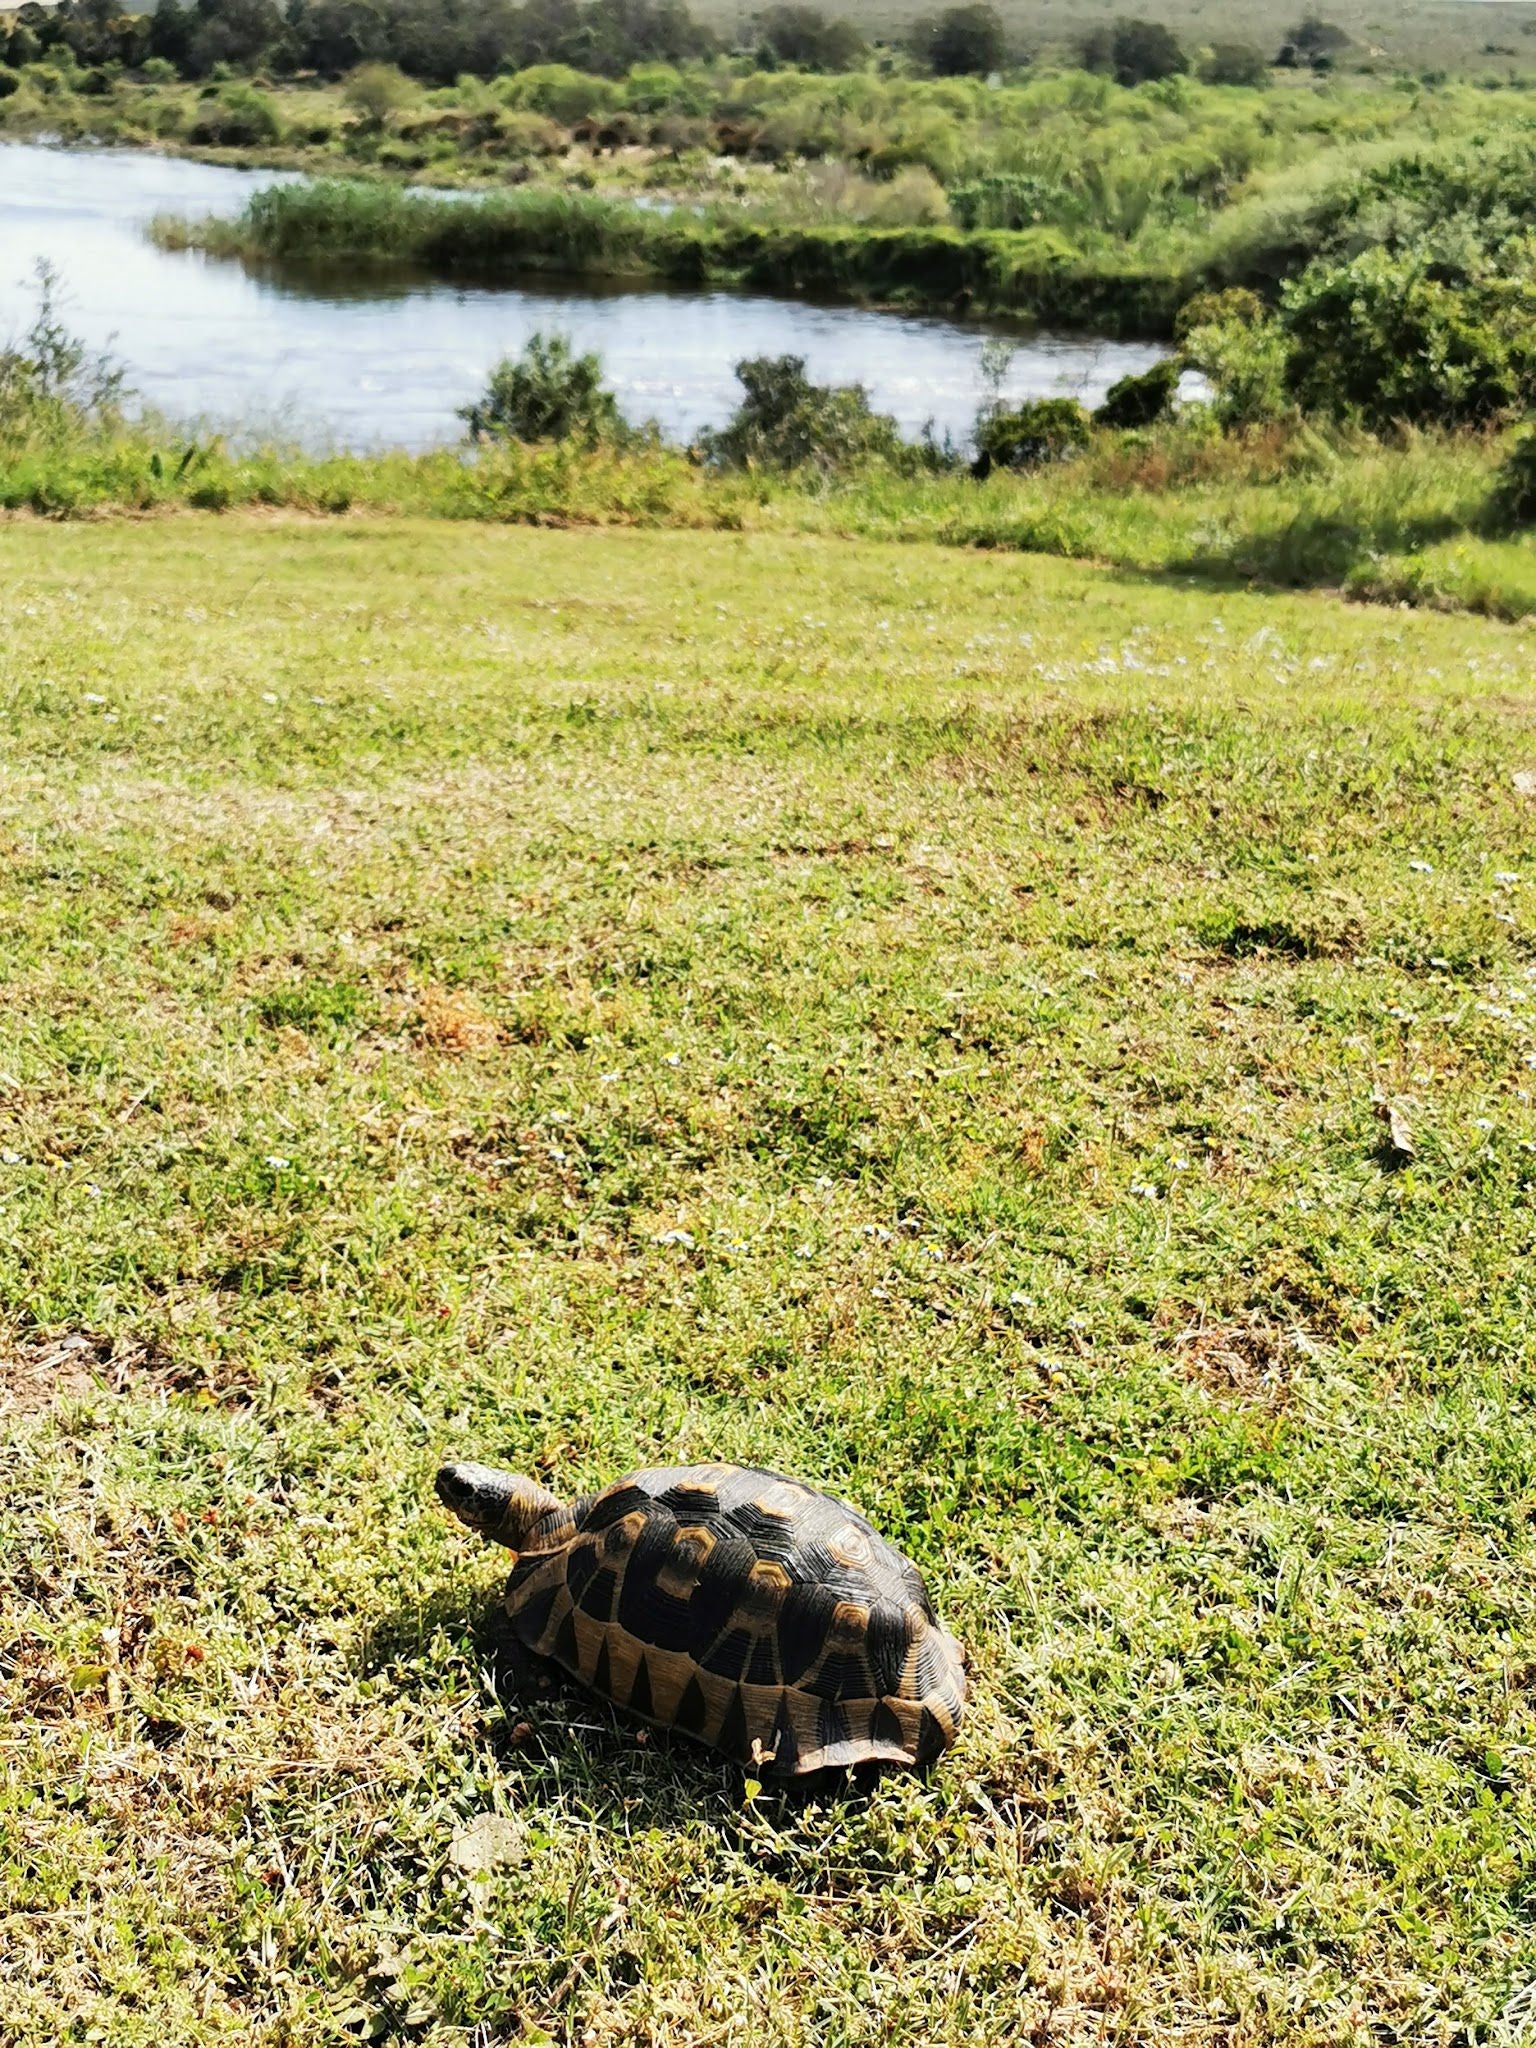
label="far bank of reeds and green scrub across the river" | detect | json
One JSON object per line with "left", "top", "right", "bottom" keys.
{"left": 18, "top": 63, "right": 1536, "bottom": 336}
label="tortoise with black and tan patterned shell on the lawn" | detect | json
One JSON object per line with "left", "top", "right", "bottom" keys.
{"left": 436, "top": 1464, "right": 965, "bottom": 1778}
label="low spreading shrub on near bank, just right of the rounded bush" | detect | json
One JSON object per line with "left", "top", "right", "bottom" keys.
{"left": 700, "top": 356, "right": 911, "bottom": 473}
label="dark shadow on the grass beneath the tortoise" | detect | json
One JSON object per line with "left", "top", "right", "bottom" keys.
{"left": 358, "top": 1585, "right": 909, "bottom": 1835}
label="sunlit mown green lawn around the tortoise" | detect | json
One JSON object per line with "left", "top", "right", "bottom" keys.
{"left": 0, "top": 516, "right": 1536, "bottom": 2048}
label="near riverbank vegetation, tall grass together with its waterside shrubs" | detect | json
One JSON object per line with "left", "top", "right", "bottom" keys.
{"left": 0, "top": 279, "right": 1536, "bottom": 618}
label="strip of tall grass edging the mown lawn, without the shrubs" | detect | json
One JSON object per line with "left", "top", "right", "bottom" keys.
{"left": 0, "top": 424, "right": 1536, "bottom": 621}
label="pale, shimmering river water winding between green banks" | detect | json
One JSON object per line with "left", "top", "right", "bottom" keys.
{"left": 0, "top": 143, "right": 1161, "bottom": 449}
